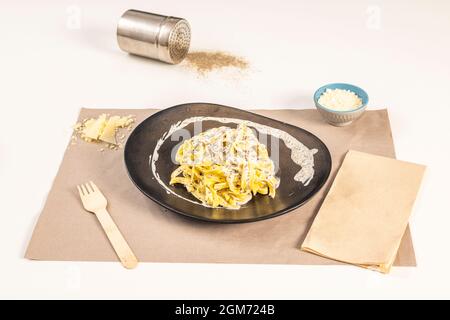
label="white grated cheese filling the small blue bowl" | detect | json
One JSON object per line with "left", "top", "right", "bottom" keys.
{"left": 319, "top": 89, "right": 362, "bottom": 111}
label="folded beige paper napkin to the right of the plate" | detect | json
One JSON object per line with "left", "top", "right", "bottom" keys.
{"left": 301, "top": 150, "right": 425, "bottom": 273}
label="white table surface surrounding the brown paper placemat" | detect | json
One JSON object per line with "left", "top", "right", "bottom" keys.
{"left": 0, "top": 0, "right": 450, "bottom": 299}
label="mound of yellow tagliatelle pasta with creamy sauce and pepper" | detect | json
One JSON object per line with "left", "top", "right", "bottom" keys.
{"left": 170, "top": 123, "right": 279, "bottom": 209}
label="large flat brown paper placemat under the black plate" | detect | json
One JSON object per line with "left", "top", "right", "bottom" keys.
{"left": 26, "top": 109, "right": 415, "bottom": 266}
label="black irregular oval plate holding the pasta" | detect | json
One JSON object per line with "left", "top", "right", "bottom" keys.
{"left": 125, "top": 103, "right": 331, "bottom": 223}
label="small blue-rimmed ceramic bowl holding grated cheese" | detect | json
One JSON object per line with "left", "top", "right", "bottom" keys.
{"left": 314, "top": 83, "right": 369, "bottom": 127}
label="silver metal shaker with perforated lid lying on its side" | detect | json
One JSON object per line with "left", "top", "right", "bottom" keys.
{"left": 117, "top": 10, "right": 191, "bottom": 64}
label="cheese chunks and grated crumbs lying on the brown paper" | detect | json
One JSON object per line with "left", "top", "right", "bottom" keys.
{"left": 72, "top": 114, "right": 135, "bottom": 152}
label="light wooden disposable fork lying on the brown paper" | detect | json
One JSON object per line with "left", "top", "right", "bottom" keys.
{"left": 77, "top": 181, "right": 138, "bottom": 269}
